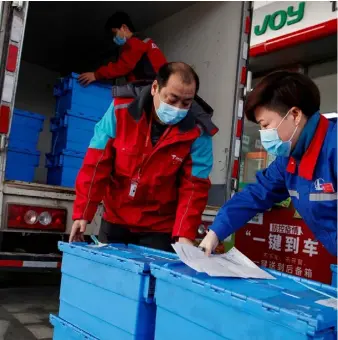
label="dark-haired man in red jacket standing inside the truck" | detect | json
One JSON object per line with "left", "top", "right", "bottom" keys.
{"left": 79, "top": 12, "right": 167, "bottom": 86}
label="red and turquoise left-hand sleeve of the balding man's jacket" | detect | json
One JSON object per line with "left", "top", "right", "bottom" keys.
{"left": 73, "top": 103, "right": 116, "bottom": 222}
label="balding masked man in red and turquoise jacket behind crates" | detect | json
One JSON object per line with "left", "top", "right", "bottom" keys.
{"left": 70, "top": 63, "right": 218, "bottom": 251}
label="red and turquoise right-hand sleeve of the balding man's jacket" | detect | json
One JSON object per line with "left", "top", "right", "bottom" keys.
{"left": 173, "top": 134, "right": 213, "bottom": 240}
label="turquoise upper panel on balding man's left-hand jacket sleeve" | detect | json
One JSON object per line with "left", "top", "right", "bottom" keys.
{"left": 89, "top": 101, "right": 116, "bottom": 150}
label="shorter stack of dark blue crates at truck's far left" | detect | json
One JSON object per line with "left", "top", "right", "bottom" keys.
{"left": 5, "top": 109, "right": 45, "bottom": 182}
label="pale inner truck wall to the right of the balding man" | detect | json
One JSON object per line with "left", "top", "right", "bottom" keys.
{"left": 146, "top": 1, "right": 242, "bottom": 184}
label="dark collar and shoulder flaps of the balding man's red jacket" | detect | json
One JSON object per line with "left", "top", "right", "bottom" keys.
{"left": 112, "top": 81, "right": 218, "bottom": 136}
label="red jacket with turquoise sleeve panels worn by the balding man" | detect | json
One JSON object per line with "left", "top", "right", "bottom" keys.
{"left": 73, "top": 84, "right": 218, "bottom": 239}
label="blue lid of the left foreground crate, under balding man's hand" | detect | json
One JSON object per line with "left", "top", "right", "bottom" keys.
{"left": 58, "top": 242, "right": 180, "bottom": 274}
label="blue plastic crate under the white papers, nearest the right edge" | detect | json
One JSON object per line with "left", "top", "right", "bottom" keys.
{"left": 151, "top": 264, "right": 337, "bottom": 340}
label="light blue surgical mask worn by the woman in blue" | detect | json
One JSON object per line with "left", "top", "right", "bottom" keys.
{"left": 259, "top": 111, "right": 298, "bottom": 157}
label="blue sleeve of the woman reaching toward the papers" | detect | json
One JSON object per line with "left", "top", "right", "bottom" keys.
{"left": 210, "top": 158, "right": 289, "bottom": 240}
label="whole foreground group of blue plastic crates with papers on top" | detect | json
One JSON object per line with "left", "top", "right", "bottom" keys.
{"left": 51, "top": 242, "right": 337, "bottom": 340}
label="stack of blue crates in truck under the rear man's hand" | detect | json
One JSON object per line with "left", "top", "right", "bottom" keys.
{"left": 46, "top": 73, "right": 112, "bottom": 187}
